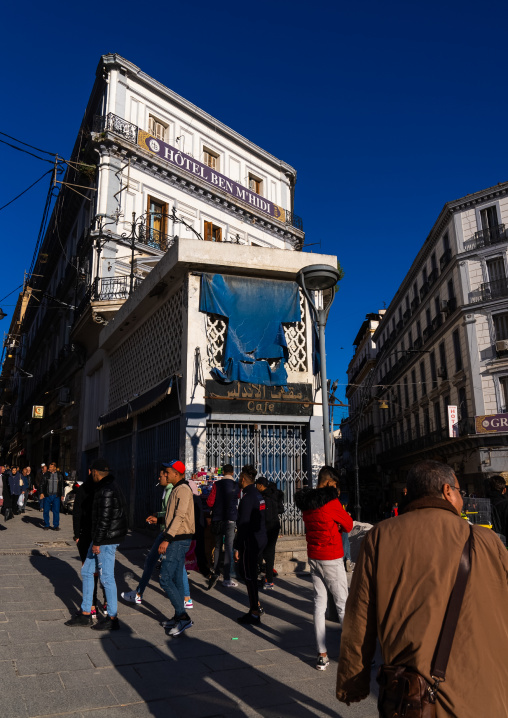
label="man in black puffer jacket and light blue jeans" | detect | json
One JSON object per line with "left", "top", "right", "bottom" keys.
{"left": 66, "top": 459, "right": 128, "bottom": 631}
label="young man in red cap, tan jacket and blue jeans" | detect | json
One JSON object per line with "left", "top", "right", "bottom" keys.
{"left": 159, "top": 461, "right": 195, "bottom": 636}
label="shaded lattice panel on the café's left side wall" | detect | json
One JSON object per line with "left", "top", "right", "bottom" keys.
{"left": 109, "top": 289, "right": 183, "bottom": 409}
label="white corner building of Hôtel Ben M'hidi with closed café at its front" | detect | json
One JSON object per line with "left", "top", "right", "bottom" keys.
{"left": 0, "top": 55, "right": 336, "bottom": 530}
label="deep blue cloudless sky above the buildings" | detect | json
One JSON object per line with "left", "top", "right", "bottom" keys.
{"left": 0, "top": 0, "right": 508, "bottom": 424}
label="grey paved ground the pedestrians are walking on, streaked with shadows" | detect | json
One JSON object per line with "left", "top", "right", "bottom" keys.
{"left": 0, "top": 508, "right": 378, "bottom": 718}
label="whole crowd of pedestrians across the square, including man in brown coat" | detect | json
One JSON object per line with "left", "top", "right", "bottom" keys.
{"left": 0, "top": 459, "right": 508, "bottom": 718}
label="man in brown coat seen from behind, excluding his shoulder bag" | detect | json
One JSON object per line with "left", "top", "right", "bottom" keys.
{"left": 337, "top": 461, "right": 508, "bottom": 718}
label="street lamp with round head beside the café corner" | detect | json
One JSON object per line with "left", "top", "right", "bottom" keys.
{"left": 296, "top": 264, "right": 340, "bottom": 466}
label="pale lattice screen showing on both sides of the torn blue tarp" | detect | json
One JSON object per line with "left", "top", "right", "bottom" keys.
{"left": 206, "top": 292, "right": 307, "bottom": 372}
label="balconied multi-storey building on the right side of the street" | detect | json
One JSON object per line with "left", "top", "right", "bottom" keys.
{"left": 351, "top": 183, "right": 508, "bottom": 498}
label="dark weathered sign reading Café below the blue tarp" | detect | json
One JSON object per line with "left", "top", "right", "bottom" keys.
{"left": 205, "top": 380, "right": 313, "bottom": 416}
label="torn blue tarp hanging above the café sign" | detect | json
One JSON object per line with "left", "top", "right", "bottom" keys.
{"left": 199, "top": 274, "right": 301, "bottom": 386}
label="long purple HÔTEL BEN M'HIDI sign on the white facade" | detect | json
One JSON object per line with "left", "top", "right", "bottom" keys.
{"left": 138, "top": 130, "right": 286, "bottom": 222}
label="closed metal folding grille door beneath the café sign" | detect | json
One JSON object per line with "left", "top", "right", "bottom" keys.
{"left": 206, "top": 422, "right": 309, "bottom": 535}
